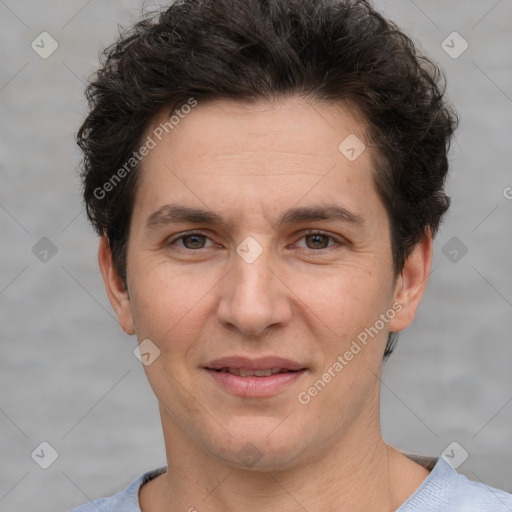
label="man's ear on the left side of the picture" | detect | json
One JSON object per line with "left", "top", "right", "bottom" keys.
{"left": 98, "top": 235, "right": 135, "bottom": 334}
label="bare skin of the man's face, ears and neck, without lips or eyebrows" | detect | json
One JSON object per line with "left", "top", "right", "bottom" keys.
{"left": 99, "top": 97, "right": 432, "bottom": 512}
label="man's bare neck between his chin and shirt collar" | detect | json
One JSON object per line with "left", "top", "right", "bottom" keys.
{"left": 140, "top": 402, "right": 428, "bottom": 512}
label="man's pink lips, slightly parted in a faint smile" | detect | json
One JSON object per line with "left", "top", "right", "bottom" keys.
{"left": 204, "top": 356, "right": 307, "bottom": 398}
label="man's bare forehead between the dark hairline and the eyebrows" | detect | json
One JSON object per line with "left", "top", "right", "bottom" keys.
{"left": 134, "top": 97, "right": 380, "bottom": 228}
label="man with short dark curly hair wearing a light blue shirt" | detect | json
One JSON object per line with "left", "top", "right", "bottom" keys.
{"left": 72, "top": 0, "right": 512, "bottom": 512}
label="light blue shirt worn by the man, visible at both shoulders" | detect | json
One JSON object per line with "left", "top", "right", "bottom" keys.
{"left": 71, "top": 457, "right": 512, "bottom": 512}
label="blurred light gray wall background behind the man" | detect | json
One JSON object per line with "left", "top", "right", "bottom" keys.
{"left": 0, "top": 0, "right": 512, "bottom": 512}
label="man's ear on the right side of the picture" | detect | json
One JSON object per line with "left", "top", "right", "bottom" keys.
{"left": 389, "top": 229, "right": 432, "bottom": 332}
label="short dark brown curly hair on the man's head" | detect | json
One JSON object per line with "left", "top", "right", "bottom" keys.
{"left": 77, "top": 0, "right": 457, "bottom": 357}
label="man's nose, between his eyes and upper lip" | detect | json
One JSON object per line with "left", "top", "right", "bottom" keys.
{"left": 217, "top": 242, "right": 292, "bottom": 337}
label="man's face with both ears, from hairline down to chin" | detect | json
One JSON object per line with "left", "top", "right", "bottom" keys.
{"left": 100, "top": 98, "right": 430, "bottom": 470}
